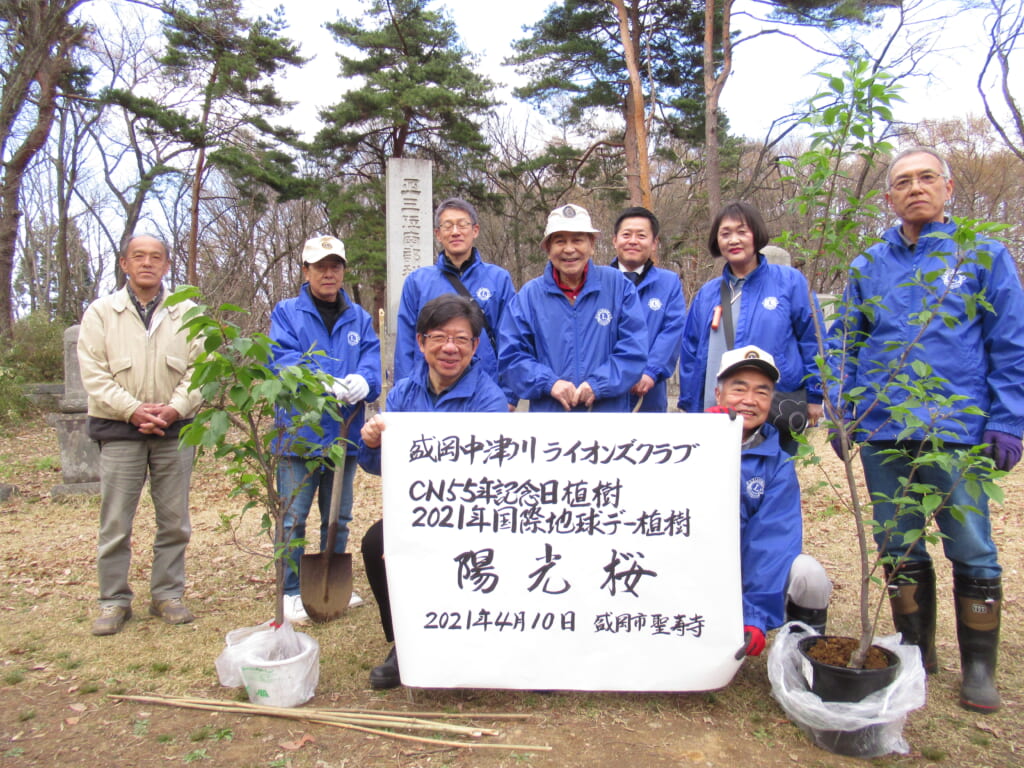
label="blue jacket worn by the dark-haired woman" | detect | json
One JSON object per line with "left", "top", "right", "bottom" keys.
{"left": 678, "top": 254, "right": 824, "bottom": 414}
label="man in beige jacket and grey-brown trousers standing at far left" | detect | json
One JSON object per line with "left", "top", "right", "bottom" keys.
{"left": 78, "top": 234, "right": 202, "bottom": 635}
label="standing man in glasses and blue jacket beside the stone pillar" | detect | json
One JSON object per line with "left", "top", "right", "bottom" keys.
{"left": 394, "top": 198, "right": 518, "bottom": 411}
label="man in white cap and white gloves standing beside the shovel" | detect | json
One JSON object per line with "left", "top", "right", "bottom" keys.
{"left": 270, "top": 237, "right": 381, "bottom": 623}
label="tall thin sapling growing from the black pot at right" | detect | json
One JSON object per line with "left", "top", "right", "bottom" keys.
{"left": 784, "top": 59, "right": 1004, "bottom": 668}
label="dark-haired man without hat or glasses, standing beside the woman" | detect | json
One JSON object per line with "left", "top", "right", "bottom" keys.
{"left": 611, "top": 207, "right": 686, "bottom": 414}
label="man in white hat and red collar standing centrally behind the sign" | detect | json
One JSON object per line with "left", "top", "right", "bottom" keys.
{"left": 499, "top": 205, "right": 647, "bottom": 412}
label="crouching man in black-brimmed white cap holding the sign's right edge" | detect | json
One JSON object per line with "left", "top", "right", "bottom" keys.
{"left": 710, "top": 345, "right": 831, "bottom": 656}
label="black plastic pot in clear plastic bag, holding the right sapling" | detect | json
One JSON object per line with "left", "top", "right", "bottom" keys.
{"left": 797, "top": 635, "right": 900, "bottom": 758}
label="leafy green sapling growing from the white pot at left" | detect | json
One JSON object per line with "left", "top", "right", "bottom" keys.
{"left": 167, "top": 286, "right": 346, "bottom": 627}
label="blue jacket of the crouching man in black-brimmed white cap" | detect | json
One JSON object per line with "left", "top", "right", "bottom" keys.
{"left": 739, "top": 424, "right": 804, "bottom": 632}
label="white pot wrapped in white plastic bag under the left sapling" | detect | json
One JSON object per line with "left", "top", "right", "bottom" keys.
{"left": 216, "top": 620, "right": 319, "bottom": 707}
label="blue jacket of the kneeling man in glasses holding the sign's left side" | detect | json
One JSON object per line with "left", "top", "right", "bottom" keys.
{"left": 359, "top": 354, "right": 509, "bottom": 475}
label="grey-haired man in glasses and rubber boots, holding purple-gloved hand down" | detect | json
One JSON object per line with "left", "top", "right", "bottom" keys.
{"left": 829, "top": 146, "right": 1024, "bottom": 713}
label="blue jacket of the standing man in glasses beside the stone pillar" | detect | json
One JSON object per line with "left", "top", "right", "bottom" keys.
{"left": 394, "top": 248, "right": 517, "bottom": 404}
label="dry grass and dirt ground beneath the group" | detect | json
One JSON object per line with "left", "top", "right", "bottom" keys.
{"left": 0, "top": 417, "right": 1024, "bottom": 768}
